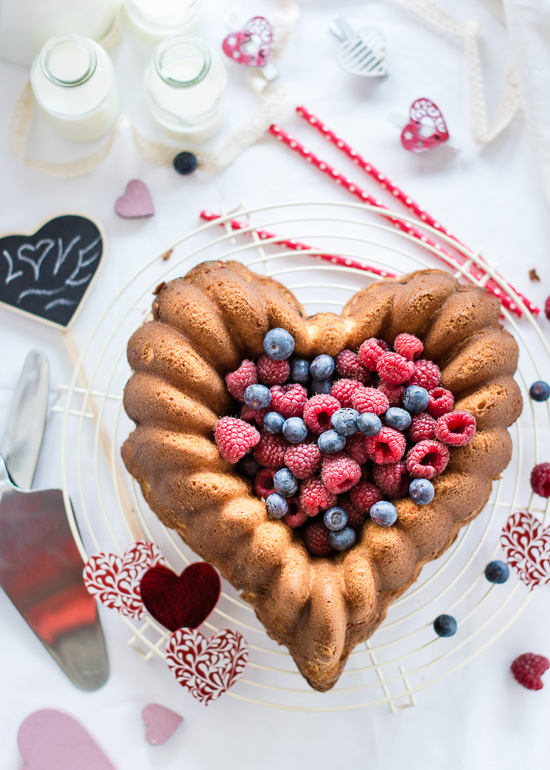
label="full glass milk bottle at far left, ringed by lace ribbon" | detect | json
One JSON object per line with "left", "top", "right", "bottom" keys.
{"left": 31, "top": 35, "right": 118, "bottom": 142}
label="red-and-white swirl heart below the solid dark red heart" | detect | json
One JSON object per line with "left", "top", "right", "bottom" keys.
{"left": 166, "top": 628, "right": 248, "bottom": 706}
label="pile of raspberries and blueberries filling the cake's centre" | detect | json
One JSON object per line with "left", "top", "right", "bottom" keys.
{"left": 215, "top": 329, "right": 476, "bottom": 556}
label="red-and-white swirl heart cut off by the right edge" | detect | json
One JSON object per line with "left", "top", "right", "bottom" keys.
{"left": 500, "top": 511, "right": 550, "bottom": 589}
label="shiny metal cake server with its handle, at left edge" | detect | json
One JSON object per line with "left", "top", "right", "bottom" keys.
{"left": 0, "top": 352, "right": 109, "bottom": 690}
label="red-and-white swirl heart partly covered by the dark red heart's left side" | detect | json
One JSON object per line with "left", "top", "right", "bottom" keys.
{"left": 83, "top": 540, "right": 164, "bottom": 620}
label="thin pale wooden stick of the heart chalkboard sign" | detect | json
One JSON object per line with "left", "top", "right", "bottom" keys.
{"left": 62, "top": 329, "right": 144, "bottom": 540}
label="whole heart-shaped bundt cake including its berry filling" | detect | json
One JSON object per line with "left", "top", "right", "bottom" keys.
{"left": 122, "top": 262, "right": 522, "bottom": 691}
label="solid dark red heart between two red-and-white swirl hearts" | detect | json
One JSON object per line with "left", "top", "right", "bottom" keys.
{"left": 141, "top": 561, "right": 221, "bottom": 631}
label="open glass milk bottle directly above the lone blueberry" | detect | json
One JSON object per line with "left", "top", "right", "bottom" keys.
{"left": 145, "top": 35, "right": 227, "bottom": 141}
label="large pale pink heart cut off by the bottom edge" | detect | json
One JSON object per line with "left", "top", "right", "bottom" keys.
{"left": 17, "top": 709, "right": 116, "bottom": 770}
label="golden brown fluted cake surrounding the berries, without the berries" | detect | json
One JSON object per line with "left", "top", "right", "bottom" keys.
{"left": 122, "top": 262, "right": 522, "bottom": 691}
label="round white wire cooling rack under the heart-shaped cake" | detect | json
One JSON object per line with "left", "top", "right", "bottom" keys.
{"left": 58, "top": 201, "right": 550, "bottom": 711}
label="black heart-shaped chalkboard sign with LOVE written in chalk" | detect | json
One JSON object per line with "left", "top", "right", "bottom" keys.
{"left": 0, "top": 214, "right": 104, "bottom": 327}
